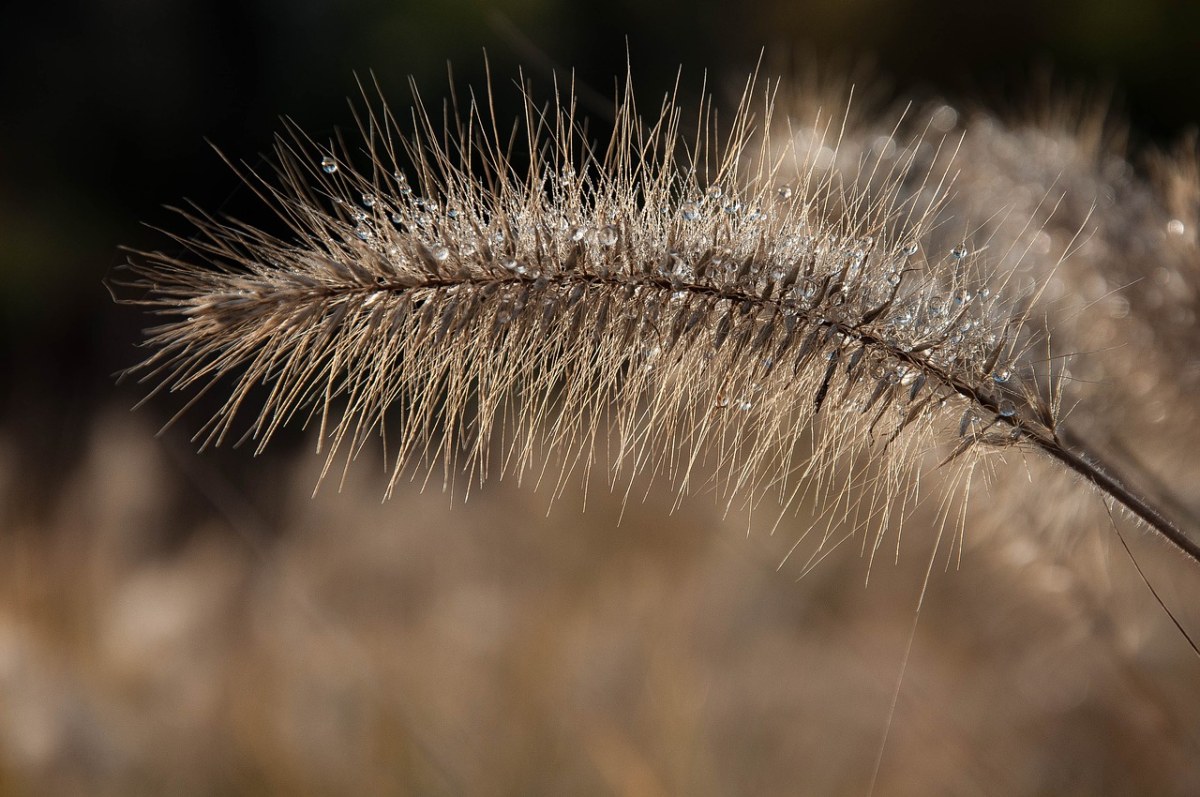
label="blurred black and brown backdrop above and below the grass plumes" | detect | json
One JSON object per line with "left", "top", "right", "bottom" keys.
{"left": 0, "top": 0, "right": 1200, "bottom": 795}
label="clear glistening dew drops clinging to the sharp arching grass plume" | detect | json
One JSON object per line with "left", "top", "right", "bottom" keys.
{"left": 320, "top": 155, "right": 1016, "bottom": 422}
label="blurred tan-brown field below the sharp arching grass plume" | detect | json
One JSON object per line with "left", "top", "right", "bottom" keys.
{"left": 0, "top": 411, "right": 1200, "bottom": 796}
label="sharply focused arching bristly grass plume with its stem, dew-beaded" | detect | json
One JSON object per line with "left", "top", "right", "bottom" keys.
{"left": 117, "top": 71, "right": 1200, "bottom": 559}
